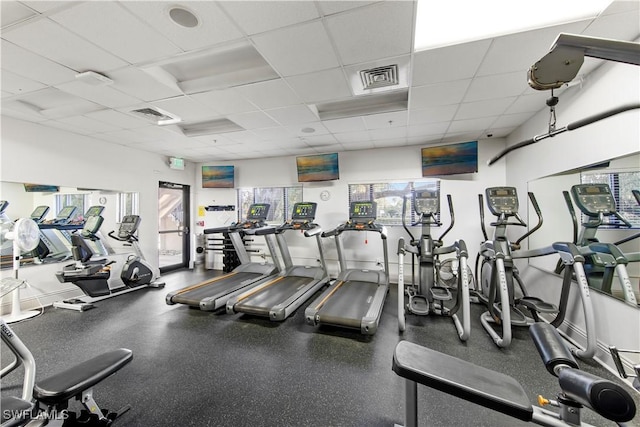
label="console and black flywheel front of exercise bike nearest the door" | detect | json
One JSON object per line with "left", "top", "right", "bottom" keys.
{"left": 109, "top": 215, "right": 165, "bottom": 288}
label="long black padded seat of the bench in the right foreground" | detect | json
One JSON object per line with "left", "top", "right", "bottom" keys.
{"left": 392, "top": 341, "right": 533, "bottom": 421}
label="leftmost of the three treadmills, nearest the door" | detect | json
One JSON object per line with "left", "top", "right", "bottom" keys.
{"left": 166, "top": 203, "right": 280, "bottom": 311}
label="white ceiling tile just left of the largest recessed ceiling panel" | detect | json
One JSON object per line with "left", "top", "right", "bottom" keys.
{"left": 107, "top": 67, "right": 182, "bottom": 102}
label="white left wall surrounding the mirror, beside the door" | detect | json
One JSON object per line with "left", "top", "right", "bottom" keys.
{"left": 0, "top": 116, "right": 195, "bottom": 307}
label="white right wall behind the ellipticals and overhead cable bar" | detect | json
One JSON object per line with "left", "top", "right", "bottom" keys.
{"left": 499, "top": 59, "right": 640, "bottom": 374}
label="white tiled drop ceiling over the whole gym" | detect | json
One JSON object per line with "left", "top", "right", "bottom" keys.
{"left": 0, "top": 0, "right": 640, "bottom": 162}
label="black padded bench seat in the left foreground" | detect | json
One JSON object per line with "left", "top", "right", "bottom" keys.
{"left": 33, "top": 348, "right": 133, "bottom": 405}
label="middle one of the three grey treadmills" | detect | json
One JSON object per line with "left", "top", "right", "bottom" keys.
{"left": 227, "top": 202, "right": 329, "bottom": 321}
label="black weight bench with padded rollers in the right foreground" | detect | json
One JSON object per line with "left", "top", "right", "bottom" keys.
{"left": 392, "top": 322, "right": 636, "bottom": 427}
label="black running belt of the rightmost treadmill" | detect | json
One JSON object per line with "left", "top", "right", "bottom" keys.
{"left": 318, "top": 281, "right": 380, "bottom": 329}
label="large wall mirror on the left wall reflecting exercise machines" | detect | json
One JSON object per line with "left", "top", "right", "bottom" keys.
{"left": 0, "top": 181, "right": 138, "bottom": 270}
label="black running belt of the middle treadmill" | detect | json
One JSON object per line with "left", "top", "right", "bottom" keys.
{"left": 234, "top": 276, "right": 314, "bottom": 316}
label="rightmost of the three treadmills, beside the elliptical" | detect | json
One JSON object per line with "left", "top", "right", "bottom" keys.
{"left": 305, "top": 201, "right": 389, "bottom": 335}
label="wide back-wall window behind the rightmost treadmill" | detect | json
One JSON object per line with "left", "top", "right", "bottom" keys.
{"left": 349, "top": 179, "right": 440, "bottom": 225}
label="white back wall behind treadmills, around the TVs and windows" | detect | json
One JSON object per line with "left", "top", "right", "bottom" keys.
{"left": 195, "top": 139, "right": 505, "bottom": 281}
